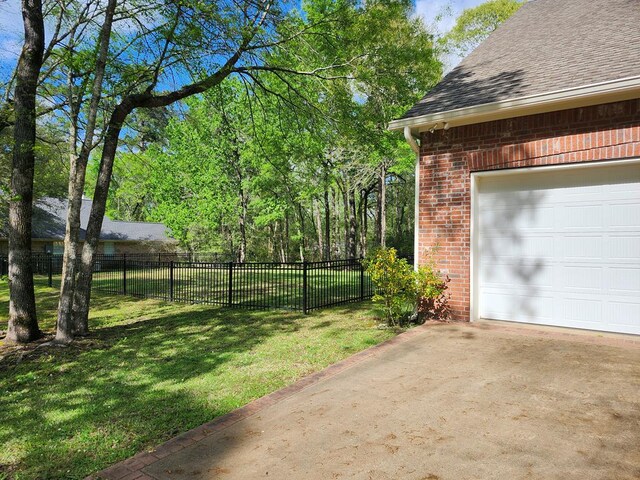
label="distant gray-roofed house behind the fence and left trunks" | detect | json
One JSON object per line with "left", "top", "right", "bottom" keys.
{"left": 0, "top": 198, "right": 176, "bottom": 255}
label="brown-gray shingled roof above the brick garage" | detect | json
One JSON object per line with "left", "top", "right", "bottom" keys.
{"left": 402, "top": 0, "right": 640, "bottom": 118}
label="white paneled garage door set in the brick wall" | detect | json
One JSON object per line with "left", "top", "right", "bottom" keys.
{"left": 474, "top": 164, "right": 640, "bottom": 334}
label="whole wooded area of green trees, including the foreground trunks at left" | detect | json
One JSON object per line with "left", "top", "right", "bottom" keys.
{"left": 0, "top": 0, "right": 519, "bottom": 342}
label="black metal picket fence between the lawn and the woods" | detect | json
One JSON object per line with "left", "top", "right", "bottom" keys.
{"left": 0, "top": 254, "right": 373, "bottom": 313}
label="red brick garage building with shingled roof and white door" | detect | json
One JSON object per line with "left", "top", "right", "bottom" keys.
{"left": 390, "top": 0, "right": 640, "bottom": 334}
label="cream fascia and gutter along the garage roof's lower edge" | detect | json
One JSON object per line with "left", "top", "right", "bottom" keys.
{"left": 389, "top": 76, "right": 640, "bottom": 134}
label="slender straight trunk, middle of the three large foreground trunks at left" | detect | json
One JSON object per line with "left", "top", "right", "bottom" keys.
{"left": 56, "top": 0, "right": 117, "bottom": 343}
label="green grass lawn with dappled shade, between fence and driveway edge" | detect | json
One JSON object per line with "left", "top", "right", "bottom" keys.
{"left": 0, "top": 279, "right": 393, "bottom": 479}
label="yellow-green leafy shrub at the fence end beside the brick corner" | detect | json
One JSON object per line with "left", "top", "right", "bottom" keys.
{"left": 366, "top": 248, "right": 416, "bottom": 326}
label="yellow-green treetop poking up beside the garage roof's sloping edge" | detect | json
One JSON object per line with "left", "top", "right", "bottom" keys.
{"left": 443, "top": 0, "right": 525, "bottom": 57}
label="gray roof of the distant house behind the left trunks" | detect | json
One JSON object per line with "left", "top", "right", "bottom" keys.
{"left": 0, "top": 198, "right": 173, "bottom": 242}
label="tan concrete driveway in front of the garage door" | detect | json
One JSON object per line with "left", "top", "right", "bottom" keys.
{"left": 97, "top": 323, "right": 640, "bottom": 480}
